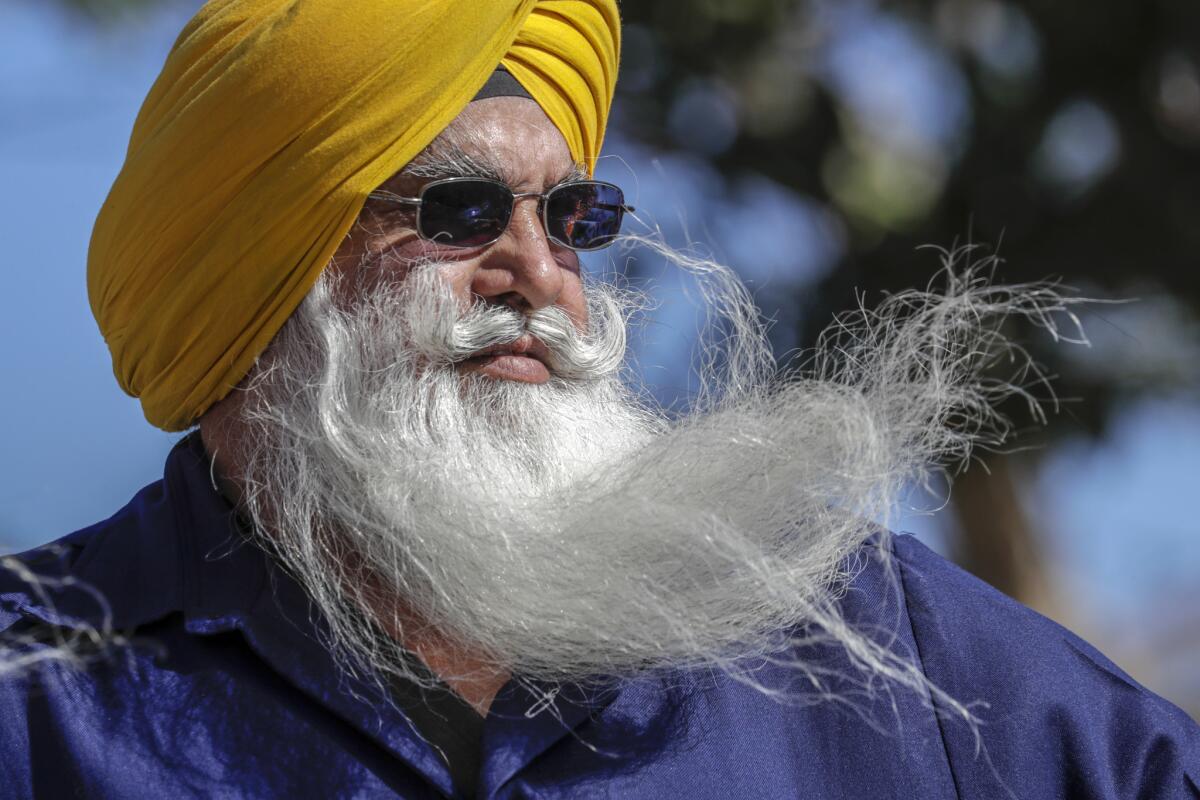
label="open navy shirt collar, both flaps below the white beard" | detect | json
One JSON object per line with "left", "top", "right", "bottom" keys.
{"left": 140, "top": 434, "right": 613, "bottom": 796}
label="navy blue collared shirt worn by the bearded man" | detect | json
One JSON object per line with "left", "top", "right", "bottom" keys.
{"left": 0, "top": 435, "right": 1200, "bottom": 800}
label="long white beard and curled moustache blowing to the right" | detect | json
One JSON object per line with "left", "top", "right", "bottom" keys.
{"left": 231, "top": 241, "right": 1080, "bottom": 708}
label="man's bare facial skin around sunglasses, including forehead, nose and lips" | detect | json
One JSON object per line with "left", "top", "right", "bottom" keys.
{"left": 331, "top": 97, "right": 587, "bottom": 384}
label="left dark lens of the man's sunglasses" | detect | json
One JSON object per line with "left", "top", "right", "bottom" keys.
{"left": 419, "top": 181, "right": 512, "bottom": 247}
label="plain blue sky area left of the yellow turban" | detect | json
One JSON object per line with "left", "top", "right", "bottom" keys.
{"left": 0, "top": 1, "right": 186, "bottom": 548}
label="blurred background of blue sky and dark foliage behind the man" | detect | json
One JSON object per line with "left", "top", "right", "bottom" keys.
{"left": 0, "top": 0, "right": 1200, "bottom": 718}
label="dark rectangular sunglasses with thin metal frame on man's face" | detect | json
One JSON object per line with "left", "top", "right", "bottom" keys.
{"left": 367, "top": 178, "right": 634, "bottom": 249}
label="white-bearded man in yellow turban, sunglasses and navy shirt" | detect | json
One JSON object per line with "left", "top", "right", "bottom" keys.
{"left": 0, "top": 0, "right": 1200, "bottom": 798}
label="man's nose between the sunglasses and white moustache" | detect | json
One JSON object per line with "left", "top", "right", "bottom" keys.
{"left": 472, "top": 197, "right": 564, "bottom": 311}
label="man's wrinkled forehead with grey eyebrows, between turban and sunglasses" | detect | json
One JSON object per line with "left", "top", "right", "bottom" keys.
{"left": 385, "top": 97, "right": 576, "bottom": 190}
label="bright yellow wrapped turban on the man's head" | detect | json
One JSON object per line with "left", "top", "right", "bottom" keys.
{"left": 88, "top": 0, "right": 620, "bottom": 431}
